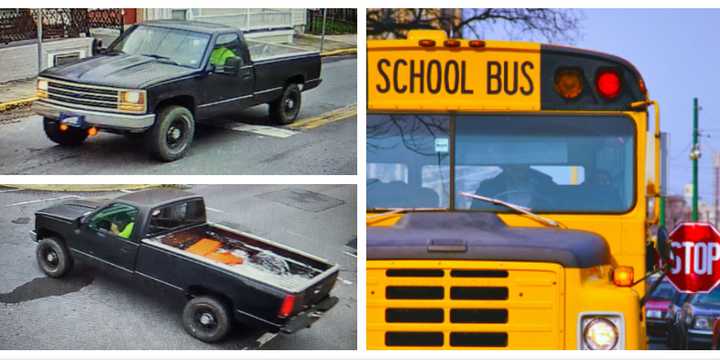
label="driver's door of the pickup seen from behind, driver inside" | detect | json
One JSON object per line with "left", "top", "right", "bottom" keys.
{"left": 80, "top": 203, "right": 139, "bottom": 272}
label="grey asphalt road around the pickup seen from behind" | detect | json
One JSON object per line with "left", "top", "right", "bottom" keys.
{"left": 0, "top": 185, "right": 357, "bottom": 350}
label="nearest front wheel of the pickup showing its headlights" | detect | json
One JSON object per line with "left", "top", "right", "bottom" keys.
{"left": 145, "top": 105, "right": 195, "bottom": 162}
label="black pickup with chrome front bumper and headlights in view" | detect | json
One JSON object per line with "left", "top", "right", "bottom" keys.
{"left": 33, "top": 20, "right": 321, "bottom": 161}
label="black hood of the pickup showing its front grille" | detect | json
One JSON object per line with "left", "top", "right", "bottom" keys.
{"left": 40, "top": 54, "right": 197, "bottom": 89}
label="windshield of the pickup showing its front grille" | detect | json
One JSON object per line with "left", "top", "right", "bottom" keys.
{"left": 110, "top": 25, "right": 210, "bottom": 68}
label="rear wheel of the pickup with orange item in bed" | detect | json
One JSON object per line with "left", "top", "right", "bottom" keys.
{"left": 183, "top": 296, "right": 231, "bottom": 342}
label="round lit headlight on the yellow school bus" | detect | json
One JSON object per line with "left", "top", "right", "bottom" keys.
{"left": 578, "top": 315, "right": 624, "bottom": 350}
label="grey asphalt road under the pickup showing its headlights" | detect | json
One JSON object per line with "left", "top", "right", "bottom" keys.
{"left": 0, "top": 57, "right": 357, "bottom": 175}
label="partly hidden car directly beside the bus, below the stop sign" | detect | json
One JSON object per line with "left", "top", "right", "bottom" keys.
{"left": 645, "top": 279, "right": 679, "bottom": 340}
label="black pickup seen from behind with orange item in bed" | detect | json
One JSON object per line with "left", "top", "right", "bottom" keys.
{"left": 31, "top": 189, "right": 339, "bottom": 342}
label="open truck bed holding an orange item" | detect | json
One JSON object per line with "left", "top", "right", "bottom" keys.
{"left": 143, "top": 224, "right": 338, "bottom": 294}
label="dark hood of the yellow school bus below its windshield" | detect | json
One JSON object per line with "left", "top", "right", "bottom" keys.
{"left": 367, "top": 212, "right": 610, "bottom": 268}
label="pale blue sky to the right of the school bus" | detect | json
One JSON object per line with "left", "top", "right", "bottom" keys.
{"left": 470, "top": 9, "right": 720, "bottom": 203}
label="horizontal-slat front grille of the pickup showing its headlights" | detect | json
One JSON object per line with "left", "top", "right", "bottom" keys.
{"left": 48, "top": 80, "right": 118, "bottom": 110}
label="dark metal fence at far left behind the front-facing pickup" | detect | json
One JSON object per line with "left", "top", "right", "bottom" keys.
{"left": 0, "top": 9, "right": 124, "bottom": 44}
